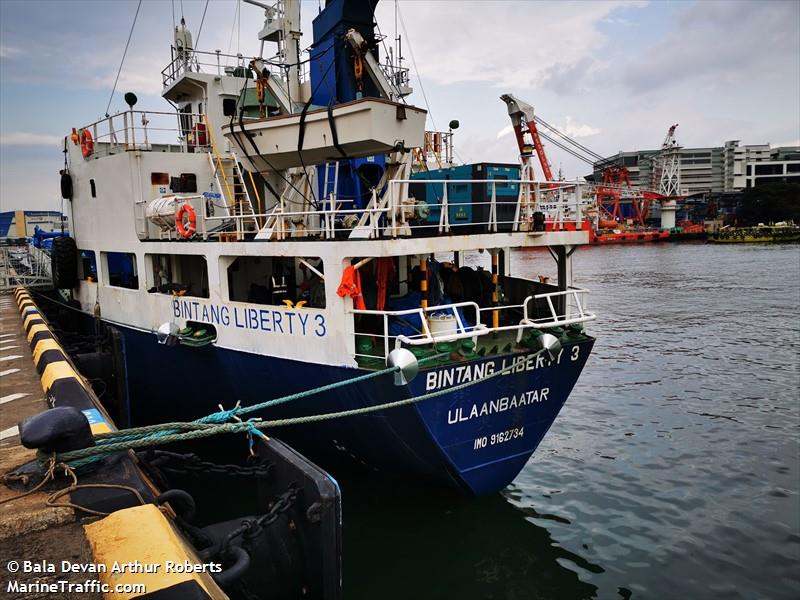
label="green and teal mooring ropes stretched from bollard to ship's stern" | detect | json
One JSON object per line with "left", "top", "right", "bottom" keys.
{"left": 48, "top": 350, "right": 544, "bottom": 468}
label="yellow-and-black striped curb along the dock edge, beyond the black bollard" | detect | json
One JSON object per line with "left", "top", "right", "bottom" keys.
{"left": 14, "top": 288, "right": 113, "bottom": 434}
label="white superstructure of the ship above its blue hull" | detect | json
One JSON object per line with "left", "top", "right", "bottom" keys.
{"left": 59, "top": 2, "right": 594, "bottom": 367}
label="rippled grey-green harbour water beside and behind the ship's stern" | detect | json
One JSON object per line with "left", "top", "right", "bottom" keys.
{"left": 342, "top": 243, "right": 800, "bottom": 600}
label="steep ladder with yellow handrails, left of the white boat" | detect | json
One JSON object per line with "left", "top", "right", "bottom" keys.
{"left": 204, "top": 115, "right": 261, "bottom": 239}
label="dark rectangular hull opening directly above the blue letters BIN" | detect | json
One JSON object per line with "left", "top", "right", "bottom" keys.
{"left": 145, "top": 254, "right": 209, "bottom": 298}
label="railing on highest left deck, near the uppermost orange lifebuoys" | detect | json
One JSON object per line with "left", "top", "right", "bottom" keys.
{"left": 79, "top": 110, "right": 209, "bottom": 155}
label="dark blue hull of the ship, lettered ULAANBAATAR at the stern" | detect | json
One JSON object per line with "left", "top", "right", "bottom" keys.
{"left": 109, "top": 326, "right": 594, "bottom": 495}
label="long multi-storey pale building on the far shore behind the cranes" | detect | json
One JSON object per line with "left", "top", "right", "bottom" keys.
{"left": 593, "top": 140, "right": 800, "bottom": 196}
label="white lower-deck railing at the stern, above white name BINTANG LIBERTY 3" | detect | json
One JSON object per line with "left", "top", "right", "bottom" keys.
{"left": 352, "top": 287, "right": 597, "bottom": 360}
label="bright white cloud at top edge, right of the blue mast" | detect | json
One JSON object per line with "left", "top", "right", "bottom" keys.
{"left": 384, "top": 0, "right": 644, "bottom": 89}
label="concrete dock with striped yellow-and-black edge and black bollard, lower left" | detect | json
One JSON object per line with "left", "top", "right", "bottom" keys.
{"left": 0, "top": 288, "right": 341, "bottom": 600}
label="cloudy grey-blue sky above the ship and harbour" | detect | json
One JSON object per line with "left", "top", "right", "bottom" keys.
{"left": 0, "top": 0, "right": 800, "bottom": 210}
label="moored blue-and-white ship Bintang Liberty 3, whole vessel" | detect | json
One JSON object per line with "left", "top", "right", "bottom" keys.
{"left": 47, "top": 0, "right": 596, "bottom": 494}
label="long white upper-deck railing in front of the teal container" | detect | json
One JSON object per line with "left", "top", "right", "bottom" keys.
{"left": 192, "top": 179, "right": 596, "bottom": 240}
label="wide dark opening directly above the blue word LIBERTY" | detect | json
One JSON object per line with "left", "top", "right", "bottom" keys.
{"left": 228, "top": 256, "right": 325, "bottom": 308}
